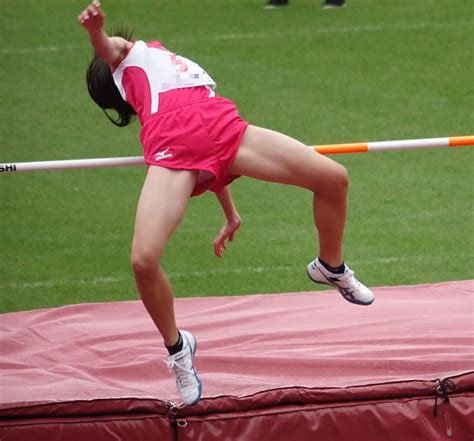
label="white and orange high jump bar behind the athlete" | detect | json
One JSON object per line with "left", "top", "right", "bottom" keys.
{"left": 0, "top": 135, "right": 474, "bottom": 173}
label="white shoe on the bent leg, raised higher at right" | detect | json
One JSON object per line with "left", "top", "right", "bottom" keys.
{"left": 307, "top": 259, "right": 375, "bottom": 305}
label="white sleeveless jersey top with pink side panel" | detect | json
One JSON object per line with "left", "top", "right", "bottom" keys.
{"left": 113, "top": 40, "right": 216, "bottom": 124}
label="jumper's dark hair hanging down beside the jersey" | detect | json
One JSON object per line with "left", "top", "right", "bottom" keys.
{"left": 86, "top": 29, "right": 137, "bottom": 127}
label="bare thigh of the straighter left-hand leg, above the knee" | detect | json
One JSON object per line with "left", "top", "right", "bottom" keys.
{"left": 132, "top": 166, "right": 197, "bottom": 259}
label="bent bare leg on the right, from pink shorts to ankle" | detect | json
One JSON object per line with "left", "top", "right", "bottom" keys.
{"left": 230, "top": 126, "right": 348, "bottom": 267}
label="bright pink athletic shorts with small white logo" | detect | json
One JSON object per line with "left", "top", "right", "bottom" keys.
{"left": 140, "top": 87, "right": 249, "bottom": 196}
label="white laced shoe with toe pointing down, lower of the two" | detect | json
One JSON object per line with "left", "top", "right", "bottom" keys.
{"left": 166, "top": 330, "right": 202, "bottom": 406}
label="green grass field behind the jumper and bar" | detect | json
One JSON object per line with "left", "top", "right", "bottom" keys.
{"left": 0, "top": 0, "right": 474, "bottom": 312}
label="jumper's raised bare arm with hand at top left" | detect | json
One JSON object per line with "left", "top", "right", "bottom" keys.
{"left": 77, "top": 0, "right": 132, "bottom": 69}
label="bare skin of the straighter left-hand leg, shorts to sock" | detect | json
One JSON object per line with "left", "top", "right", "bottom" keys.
{"left": 132, "top": 167, "right": 197, "bottom": 346}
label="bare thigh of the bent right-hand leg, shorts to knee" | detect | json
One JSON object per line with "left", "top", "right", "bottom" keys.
{"left": 230, "top": 125, "right": 345, "bottom": 190}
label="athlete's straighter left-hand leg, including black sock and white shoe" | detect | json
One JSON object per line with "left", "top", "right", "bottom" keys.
{"left": 132, "top": 166, "right": 202, "bottom": 405}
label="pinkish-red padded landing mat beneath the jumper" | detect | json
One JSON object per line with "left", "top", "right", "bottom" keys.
{"left": 0, "top": 280, "right": 474, "bottom": 441}
